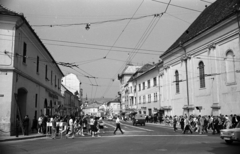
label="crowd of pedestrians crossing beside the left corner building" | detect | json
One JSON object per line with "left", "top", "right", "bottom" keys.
{"left": 35, "top": 115, "right": 105, "bottom": 139}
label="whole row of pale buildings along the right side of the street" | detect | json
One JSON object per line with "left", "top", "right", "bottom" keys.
{"left": 119, "top": 0, "right": 240, "bottom": 116}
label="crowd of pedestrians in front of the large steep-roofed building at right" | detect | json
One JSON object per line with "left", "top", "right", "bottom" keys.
{"left": 164, "top": 114, "right": 240, "bottom": 134}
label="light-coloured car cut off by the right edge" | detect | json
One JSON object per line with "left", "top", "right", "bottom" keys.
{"left": 220, "top": 122, "right": 240, "bottom": 144}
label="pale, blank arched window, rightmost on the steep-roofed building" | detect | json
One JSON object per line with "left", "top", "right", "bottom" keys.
{"left": 225, "top": 50, "right": 235, "bottom": 83}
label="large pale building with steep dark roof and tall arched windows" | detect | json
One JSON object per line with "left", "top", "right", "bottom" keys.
{"left": 160, "top": 0, "right": 240, "bottom": 115}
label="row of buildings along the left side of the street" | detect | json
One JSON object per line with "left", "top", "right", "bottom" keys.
{"left": 0, "top": 5, "right": 81, "bottom": 135}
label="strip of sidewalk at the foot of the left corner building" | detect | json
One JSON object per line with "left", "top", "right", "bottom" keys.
{"left": 0, "top": 133, "right": 46, "bottom": 142}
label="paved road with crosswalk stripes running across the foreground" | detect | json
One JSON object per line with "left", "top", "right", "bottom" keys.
{"left": 0, "top": 121, "right": 240, "bottom": 154}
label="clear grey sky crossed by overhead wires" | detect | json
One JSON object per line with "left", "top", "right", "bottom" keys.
{"left": 0, "top": 0, "right": 215, "bottom": 99}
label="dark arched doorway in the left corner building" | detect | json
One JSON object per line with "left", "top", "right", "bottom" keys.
{"left": 17, "top": 88, "right": 28, "bottom": 119}
